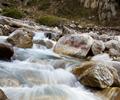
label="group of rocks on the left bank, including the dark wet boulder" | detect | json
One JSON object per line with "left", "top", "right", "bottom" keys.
{"left": 0, "top": 16, "right": 59, "bottom": 60}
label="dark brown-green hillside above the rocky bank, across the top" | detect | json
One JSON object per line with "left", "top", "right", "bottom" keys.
{"left": 0, "top": 0, "right": 120, "bottom": 26}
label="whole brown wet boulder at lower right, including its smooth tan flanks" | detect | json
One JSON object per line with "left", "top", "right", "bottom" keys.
{"left": 73, "top": 62, "right": 120, "bottom": 88}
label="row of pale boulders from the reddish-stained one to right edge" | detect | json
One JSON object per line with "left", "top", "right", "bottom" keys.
{"left": 54, "top": 29, "right": 120, "bottom": 58}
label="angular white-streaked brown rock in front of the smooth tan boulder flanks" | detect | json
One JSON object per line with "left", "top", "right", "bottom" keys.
{"left": 80, "top": 63, "right": 113, "bottom": 88}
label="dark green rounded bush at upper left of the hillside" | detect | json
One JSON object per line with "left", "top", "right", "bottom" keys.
{"left": 2, "top": 8, "right": 24, "bottom": 19}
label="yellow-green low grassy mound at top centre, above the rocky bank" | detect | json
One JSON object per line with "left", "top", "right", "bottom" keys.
{"left": 36, "top": 15, "right": 67, "bottom": 26}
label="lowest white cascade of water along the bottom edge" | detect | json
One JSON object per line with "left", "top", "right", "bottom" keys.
{"left": 3, "top": 85, "right": 99, "bottom": 100}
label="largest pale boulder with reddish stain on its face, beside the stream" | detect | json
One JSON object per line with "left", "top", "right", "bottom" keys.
{"left": 54, "top": 34, "right": 93, "bottom": 58}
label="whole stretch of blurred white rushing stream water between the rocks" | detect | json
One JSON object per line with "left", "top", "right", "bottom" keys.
{"left": 0, "top": 32, "right": 99, "bottom": 100}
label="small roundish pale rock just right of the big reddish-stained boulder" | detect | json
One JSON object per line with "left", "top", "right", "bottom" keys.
{"left": 91, "top": 40, "right": 105, "bottom": 55}
